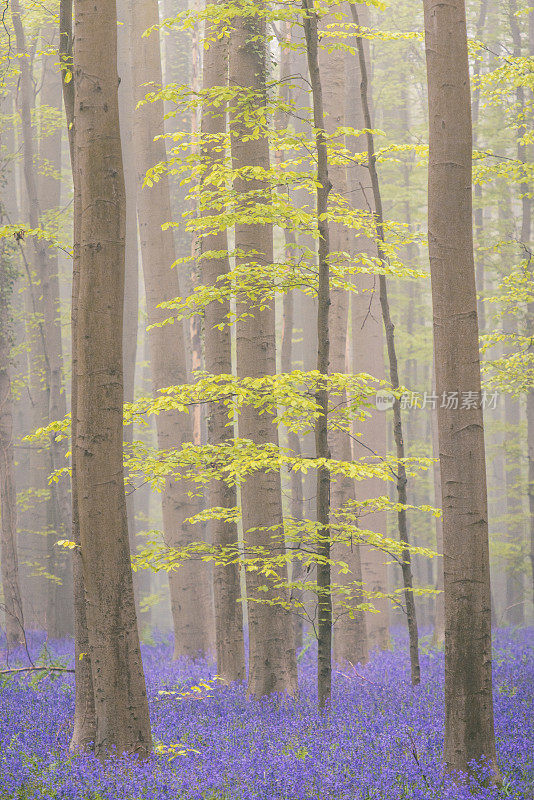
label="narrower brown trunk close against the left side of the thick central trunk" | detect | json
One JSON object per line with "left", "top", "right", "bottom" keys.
{"left": 201, "top": 3, "right": 246, "bottom": 683}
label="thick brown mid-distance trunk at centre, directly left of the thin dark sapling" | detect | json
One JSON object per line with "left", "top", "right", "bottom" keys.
{"left": 229, "top": 0, "right": 297, "bottom": 697}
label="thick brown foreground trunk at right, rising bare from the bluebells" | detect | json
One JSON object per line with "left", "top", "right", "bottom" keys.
{"left": 424, "top": 0, "right": 498, "bottom": 776}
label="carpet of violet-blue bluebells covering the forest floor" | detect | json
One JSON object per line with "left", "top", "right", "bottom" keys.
{"left": 0, "top": 630, "right": 534, "bottom": 800}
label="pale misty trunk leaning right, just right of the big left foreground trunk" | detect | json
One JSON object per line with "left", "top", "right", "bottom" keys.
{"left": 129, "top": 0, "right": 214, "bottom": 658}
